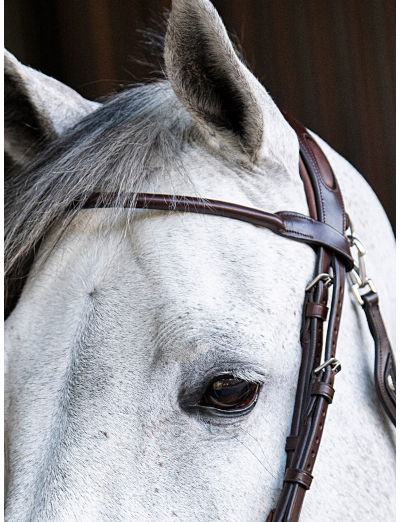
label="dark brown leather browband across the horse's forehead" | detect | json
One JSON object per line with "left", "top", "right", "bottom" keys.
{"left": 78, "top": 192, "right": 354, "bottom": 271}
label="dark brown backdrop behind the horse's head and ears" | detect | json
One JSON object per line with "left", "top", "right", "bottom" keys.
{"left": 5, "top": 0, "right": 395, "bottom": 230}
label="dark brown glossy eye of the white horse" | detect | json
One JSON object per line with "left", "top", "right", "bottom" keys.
{"left": 200, "top": 375, "right": 260, "bottom": 413}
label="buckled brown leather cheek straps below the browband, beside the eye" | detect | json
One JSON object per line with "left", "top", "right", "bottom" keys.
{"left": 273, "top": 254, "right": 344, "bottom": 522}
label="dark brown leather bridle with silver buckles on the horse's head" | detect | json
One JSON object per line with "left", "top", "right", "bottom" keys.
{"left": 71, "top": 114, "right": 396, "bottom": 522}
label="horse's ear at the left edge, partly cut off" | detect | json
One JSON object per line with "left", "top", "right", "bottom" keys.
{"left": 4, "top": 51, "right": 99, "bottom": 165}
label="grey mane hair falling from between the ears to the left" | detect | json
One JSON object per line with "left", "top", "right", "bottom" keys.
{"left": 5, "top": 81, "right": 193, "bottom": 312}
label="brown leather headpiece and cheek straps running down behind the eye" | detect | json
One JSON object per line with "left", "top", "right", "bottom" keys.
{"left": 270, "top": 115, "right": 347, "bottom": 522}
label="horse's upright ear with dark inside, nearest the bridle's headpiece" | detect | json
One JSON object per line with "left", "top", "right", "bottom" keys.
{"left": 164, "top": 0, "right": 298, "bottom": 162}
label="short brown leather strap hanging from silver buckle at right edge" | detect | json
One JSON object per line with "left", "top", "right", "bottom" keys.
{"left": 362, "top": 291, "right": 396, "bottom": 426}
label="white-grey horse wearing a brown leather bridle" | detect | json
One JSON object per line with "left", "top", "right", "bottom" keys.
{"left": 5, "top": 0, "right": 395, "bottom": 522}
